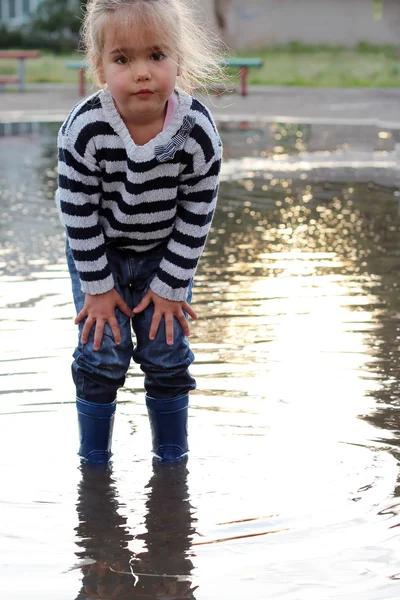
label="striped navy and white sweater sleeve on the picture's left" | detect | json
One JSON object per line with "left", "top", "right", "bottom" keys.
{"left": 56, "top": 130, "right": 114, "bottom": 295}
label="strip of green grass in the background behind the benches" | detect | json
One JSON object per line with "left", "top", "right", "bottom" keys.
{"left": 0, "top": 42, "right": 400, "bottom": 88}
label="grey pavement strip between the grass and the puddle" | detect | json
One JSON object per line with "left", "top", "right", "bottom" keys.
{"left": 0, "top": 84, "right": 400, "bottom": 127}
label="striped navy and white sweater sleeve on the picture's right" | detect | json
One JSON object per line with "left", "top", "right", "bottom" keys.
{"left": 150, "top": 126, "right": 222, "bottom": 301}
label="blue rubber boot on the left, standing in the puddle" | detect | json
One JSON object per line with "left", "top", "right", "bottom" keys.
{"left": 76, "top": 398, "right": 117, "bottom": 465}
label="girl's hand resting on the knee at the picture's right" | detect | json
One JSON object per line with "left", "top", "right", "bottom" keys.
{"left": 133, "top": 290, "right": 199, "bottom": 346}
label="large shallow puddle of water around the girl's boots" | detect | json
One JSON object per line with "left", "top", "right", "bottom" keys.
{"left": 0, "top": 123, "right": 400, "bottom": 600}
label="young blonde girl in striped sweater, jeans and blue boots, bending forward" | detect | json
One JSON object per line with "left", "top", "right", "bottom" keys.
{"left": 56, "top": 0, "right": 222, "bottom": 463}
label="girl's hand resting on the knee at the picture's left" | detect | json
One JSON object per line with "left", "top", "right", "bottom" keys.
{"left": 74, "top": 289, "right": 132, "bottom": 350}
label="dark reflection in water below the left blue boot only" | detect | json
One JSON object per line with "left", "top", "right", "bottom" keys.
{"left": 76, "top": 464, "right": 135, "bottom": 600}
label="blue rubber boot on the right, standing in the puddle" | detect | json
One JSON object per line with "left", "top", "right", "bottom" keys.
{"left": 146, "top": 394, "right": 189, "bottom": 462}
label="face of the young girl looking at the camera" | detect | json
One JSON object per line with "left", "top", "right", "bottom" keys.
{"left": 99, "top": 20, "right": 180, "bottom": 124}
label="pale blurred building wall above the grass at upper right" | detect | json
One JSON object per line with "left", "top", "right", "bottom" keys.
{"left": 200, "top": 0, "right": 400, "bottom": 50}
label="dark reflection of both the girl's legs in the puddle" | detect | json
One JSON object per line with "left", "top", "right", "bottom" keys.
{"left": 76, "top": 464, "right": 196, "bottom": 600}
